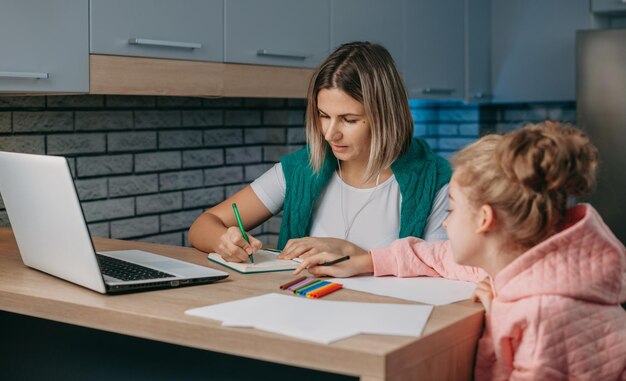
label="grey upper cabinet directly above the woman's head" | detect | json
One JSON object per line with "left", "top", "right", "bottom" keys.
{"left": 330, "top": 0, "right": 406, "bottom": 72}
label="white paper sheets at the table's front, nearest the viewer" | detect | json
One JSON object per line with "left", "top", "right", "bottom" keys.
{"left": 185, "top": 293, "right": 433, "bottom": 344}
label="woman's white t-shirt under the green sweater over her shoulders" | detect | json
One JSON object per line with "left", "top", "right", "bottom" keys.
{"left": 250, "top": 163, "right": 448, "bottom": 250}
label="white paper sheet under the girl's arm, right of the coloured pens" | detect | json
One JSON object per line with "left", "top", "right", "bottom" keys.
{"left": 330, "top": 276, "right": 476, "bottom": 306}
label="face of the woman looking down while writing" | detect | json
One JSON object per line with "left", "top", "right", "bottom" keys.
{"left": 317, "top": 88, "right": 372, "bottom": 163}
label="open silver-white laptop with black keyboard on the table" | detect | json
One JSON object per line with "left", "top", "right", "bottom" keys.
{"left": 0, "top": 151, "right": 228, "bottom": 294}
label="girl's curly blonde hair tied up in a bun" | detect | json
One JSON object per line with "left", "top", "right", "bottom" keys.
{"left": 452, "top": 121, "right": 598, "bottom": 249}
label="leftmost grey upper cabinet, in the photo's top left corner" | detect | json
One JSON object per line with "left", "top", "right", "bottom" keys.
{"left": 0, "top": 0, "right": 89, "bottom": 93}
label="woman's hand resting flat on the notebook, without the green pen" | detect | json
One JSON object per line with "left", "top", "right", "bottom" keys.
{"left": 278, "top": 237, "right": 367, "bottom": 259}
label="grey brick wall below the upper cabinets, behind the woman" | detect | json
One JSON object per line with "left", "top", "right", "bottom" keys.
{"left": 0, "top": 95, "right": 576, "bottom": 245}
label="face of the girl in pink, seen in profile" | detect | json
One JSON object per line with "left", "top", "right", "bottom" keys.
{"left": 443, "top": 175, "right": 485, "bottom": 267}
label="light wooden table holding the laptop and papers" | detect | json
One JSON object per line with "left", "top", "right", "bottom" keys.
{"left": 0, "top": 228, "right": 483, "bottom": 380}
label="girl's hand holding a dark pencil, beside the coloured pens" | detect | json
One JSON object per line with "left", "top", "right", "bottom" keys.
{"left": 293, "top": 252, "right": 374, "bottom": 278}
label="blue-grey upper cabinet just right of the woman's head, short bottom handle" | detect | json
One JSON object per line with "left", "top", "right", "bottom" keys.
{"left": 404, "top": 0, "right": 465, "bottom": 99}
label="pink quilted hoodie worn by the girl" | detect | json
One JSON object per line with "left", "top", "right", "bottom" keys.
{"left": 371, "top": 204, "right": 626, "bottom": 380}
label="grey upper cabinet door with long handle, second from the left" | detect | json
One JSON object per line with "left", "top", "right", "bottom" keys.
{"left": 90, "top": 0, "right": 224, "bottom": 62}
